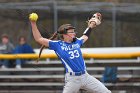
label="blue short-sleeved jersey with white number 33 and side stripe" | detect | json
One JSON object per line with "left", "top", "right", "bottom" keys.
{"left": 49, "top": 38, "right": 86, "bottom": 72}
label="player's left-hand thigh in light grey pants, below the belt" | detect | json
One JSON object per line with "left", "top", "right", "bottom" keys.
{"left": 63, "top": 77, "right": 81, "bottom": 93}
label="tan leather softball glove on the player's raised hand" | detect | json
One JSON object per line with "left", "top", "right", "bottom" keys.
{"left": 89, "top": 13, "right": 102, "bottom": 25}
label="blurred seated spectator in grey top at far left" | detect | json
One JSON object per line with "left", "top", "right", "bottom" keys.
{"left": 0, "top": 34, "right": 14, "bottom": 68}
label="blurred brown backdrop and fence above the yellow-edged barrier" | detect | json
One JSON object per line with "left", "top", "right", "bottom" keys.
{"left": 0, "top": 0, "right": 140, "bottom": 48}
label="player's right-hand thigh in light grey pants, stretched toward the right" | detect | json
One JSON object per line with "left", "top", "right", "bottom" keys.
{"left": 85, "top": 75, "right": 111, "bottom": 93}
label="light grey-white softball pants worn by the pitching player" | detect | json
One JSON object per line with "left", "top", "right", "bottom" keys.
{"left": 63, "top": 73, "right": 111, "bottom": 93}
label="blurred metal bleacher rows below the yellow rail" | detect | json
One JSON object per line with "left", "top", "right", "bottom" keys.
{"left": 0, "top": 47, "right": 140, "bottom": 93}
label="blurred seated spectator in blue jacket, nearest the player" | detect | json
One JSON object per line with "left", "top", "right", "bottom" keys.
{"left": 13, "top": 36, "right": 34, "bottom": 69}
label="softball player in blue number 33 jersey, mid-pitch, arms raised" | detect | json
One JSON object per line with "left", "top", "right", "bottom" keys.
{"left": 30, "top": 14, "right": 111, "bottom": 93}
